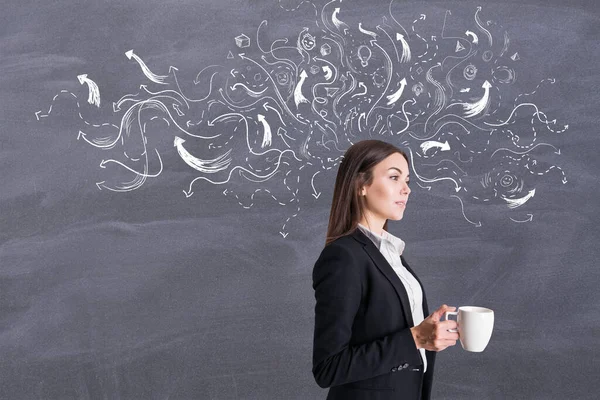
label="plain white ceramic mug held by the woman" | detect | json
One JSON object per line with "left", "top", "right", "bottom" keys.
{"left": 444, "top": 306, "right": 494, "bottom": 352}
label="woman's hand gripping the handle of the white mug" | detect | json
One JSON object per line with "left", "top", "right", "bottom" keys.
{"left": 410, "top": 304, "right": 458, "bottom": 351}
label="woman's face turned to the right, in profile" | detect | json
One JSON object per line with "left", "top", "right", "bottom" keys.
{"left": 361, "top": 153, "right": 410, "bottom": 226}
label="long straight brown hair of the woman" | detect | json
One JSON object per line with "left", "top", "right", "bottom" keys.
{"left": 325, "top": 140, "right": 408, "bottom": 245}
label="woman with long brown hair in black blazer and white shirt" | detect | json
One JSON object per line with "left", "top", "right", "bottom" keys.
{"left": 313, "top": 140, "right": 458, "bottom": 400}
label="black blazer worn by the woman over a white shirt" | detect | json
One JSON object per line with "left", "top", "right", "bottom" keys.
{"left": 312, "top": 229, "right": 436, "bottom": 400}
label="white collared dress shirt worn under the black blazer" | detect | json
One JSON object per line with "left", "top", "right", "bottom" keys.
{"left": 358, "top": 224, "right": 427, "bottom": 373}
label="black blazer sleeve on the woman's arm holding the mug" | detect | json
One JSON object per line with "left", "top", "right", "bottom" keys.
{"left": 312, "top": 243, "right": 422, "bottom": 388}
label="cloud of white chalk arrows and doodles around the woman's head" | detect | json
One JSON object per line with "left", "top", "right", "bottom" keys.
{"left": 35, "top": 0, "right": 569, "bottom": 238}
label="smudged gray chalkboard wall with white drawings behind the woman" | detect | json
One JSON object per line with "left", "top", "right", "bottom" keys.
{"left": 0, "top": 0, "right": 600, "bottom": 399}
